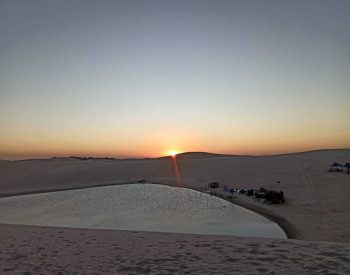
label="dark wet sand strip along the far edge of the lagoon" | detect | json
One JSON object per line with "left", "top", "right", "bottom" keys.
{"left": 0, "top": 181, "right": 292, "bottom": 239}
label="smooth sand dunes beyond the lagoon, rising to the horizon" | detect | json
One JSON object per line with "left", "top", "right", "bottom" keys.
{"left": 0, "top": 149, "right": 350, "bottom": 242}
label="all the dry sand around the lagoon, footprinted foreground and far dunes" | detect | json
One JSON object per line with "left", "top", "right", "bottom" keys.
{"left": 0, "top": 149, "right": 350, "bottom": 274}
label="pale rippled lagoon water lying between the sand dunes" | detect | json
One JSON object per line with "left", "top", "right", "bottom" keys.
{"left": 0, "top": 184, "right": 286, "bottom": 238}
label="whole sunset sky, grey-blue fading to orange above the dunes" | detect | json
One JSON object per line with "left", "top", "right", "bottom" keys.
{"left": 0, "top": 0, "right": 350, "bottom": 159}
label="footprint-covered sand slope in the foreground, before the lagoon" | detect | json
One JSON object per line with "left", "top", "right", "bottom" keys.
{"left": 0, "top": 225, "right": 350, "bottom": 275}
